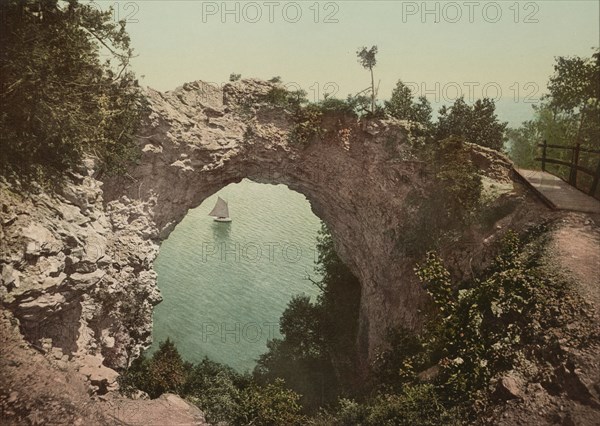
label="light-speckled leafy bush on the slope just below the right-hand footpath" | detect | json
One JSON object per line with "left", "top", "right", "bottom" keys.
{"left": 376, "top": 226, "right": 577, "bottom": 419}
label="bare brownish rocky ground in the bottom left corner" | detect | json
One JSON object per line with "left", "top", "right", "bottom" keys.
{"left": 0, "top": 311, "right": 207, "bottom": 426}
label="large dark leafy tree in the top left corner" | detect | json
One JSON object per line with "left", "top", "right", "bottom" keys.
{"left": 0, "top": 0, "right": 143, "bottom": 180}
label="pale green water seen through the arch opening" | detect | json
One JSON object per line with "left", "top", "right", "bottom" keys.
{"left": 150, "top": 180, "right": 320, "bottom": 371}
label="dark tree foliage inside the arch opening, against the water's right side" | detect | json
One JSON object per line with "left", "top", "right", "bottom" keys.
{"left": 254, "top": 225, "right": 360, "bottom": 411}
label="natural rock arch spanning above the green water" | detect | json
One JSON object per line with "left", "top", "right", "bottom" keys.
{"left": 105, "top": 80, "right": 442, "bottom": 364}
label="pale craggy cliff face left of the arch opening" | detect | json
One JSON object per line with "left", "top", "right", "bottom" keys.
{"left": 0, "top": 161, "right": 161, "bottom": 367}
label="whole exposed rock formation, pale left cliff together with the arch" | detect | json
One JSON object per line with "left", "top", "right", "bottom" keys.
{"left": 0, "top": 80, "right": 512, "bottom": 367}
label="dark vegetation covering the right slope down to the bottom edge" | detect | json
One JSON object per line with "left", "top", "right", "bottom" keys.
{"left": 317, "top": 225, "right": 593, "bottom": 425}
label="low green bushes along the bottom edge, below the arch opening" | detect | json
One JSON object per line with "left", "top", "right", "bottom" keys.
{"left": 119, "top": 339, "right": 303, "bottom": 426}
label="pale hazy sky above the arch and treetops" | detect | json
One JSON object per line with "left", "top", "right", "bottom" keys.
{"left": 82, "top": 0, "right": 600, "bottom": 125}
